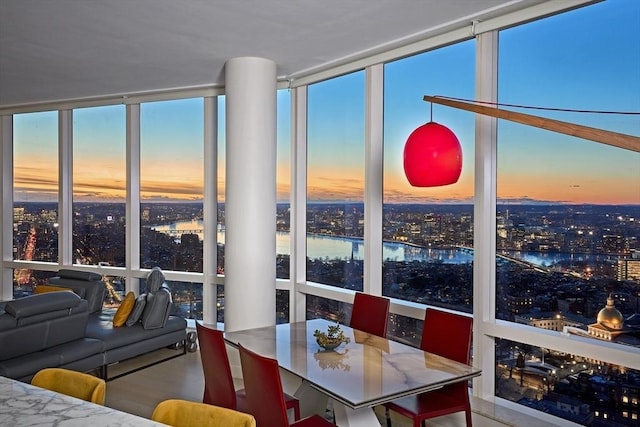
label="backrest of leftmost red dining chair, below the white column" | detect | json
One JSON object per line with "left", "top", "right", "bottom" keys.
{"left": 196, "top": 322, "right": 238, "bottom": 409}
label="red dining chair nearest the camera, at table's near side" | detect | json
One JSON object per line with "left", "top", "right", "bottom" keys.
{"left": 239, "top": 345, "right": 336, "bottom": 427}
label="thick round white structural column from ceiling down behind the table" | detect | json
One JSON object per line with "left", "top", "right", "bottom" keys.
{"left": 224, "top": 57, "right": 277, "bottom": 331}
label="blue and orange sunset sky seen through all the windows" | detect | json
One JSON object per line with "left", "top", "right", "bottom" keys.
{"left": 14, "top": 0, "right": 640, "bottom": 205}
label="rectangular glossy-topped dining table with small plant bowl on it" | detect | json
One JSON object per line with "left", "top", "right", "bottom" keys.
{"left": 225, "top": 319, "right": 482, "bottom": 427}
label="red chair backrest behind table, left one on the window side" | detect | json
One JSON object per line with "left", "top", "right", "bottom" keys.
{"left": 349, "top": 292, "right": 389, "bottom": 338}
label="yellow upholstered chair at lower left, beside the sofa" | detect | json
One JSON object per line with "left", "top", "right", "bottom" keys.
{"left": 31, "top": 368, "right": 107, "bottom": 405}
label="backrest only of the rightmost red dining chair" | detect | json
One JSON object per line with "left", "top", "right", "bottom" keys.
{"left": 420, "top": 308, "right": 473, "bottom": 364}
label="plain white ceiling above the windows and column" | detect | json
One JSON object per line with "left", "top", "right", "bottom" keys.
{"left": 0, "top": 0, "right": 557, "bottom": 107}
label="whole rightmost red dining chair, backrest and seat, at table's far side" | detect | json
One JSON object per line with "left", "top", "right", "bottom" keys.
{"left": 384, "top": 308, "right": 473, "bottom": 427}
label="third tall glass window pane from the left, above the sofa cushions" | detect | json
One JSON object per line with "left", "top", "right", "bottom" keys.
{"left": 140, "top": 98, "right": 204, "bottom": 272}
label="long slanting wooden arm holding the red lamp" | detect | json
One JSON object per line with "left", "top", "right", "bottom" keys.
{"left": 423, "top": 95, "right": 640, "bottom": 153}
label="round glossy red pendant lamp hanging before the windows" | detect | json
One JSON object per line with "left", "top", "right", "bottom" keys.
{"left": 404, "top": 122, "right": 462, "bottom": 187}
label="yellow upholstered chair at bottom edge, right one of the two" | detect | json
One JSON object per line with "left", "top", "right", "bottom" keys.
{"left": 151, "top": 399, "right": 256, "bottom": 427}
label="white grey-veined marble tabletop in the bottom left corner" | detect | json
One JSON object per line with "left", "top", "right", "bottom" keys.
{"left": 0, "top": 376, "right": 165, "bottom": 427}
